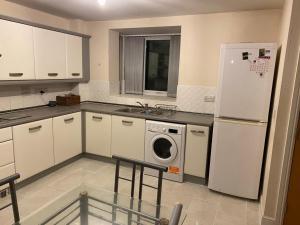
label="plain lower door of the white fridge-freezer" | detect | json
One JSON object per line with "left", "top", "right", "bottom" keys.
{"left": 208, "top": 119, "right": 267, "bottom": 199}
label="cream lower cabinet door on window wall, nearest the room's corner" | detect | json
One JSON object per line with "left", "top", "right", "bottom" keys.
{"left": 85, "top": 112, "right": 111, "bottom": 157}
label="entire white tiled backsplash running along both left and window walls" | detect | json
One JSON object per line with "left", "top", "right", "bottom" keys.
{"left": 0, "top": 80, "right": 216, "bottom": 113}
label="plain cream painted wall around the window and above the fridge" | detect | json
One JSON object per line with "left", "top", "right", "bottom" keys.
{"left": 87, "top": 10, "right": 281, "bottom": 86}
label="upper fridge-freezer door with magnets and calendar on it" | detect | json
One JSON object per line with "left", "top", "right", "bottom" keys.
{"left": 215, "top": 44, "right": 276, "bottom": 122}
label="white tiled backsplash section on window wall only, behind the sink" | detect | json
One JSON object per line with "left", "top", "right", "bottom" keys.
{"left": 74, "top": 80, "right": 216, "bottom": 114}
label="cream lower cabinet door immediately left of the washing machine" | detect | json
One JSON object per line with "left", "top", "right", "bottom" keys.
{"left": 111, "top": 116, "right": 145, "bottom": 160}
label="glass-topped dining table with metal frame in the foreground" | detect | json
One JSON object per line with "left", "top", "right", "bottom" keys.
{"left": 19, "top": 184, "right": 186, "bottom": 225}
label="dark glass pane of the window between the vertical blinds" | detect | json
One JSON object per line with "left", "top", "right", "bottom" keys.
{"left": 145, "top": 40, "right": 170, "bottom": 91}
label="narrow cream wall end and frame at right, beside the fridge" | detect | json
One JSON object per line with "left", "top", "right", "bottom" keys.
{"left": 261, "top": 0, "right": 300, "bottom": 224}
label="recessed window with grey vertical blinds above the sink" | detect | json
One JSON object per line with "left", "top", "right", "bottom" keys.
{"left": 120, "top": 35, "right": 180, "bottom": 97}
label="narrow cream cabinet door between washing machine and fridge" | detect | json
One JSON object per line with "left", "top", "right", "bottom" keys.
{"left": 184, "top": 125, "right": 209, "bottom": 178}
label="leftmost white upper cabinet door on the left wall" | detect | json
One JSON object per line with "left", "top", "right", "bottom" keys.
{"left": 0, "top": 20, "right": 35, "bottom": 80}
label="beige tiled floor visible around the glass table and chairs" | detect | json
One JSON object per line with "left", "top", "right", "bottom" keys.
{"left": 0, "top": 159, "right": 259, "bottom": 225}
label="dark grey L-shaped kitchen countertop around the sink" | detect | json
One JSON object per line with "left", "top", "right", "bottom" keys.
{"left": 0, "top": 102, "right": 213, "bottom": 128}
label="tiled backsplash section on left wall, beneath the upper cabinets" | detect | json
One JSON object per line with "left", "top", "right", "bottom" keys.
{"left": 0, "top": 84, "right": 74, "bottom": 111}
